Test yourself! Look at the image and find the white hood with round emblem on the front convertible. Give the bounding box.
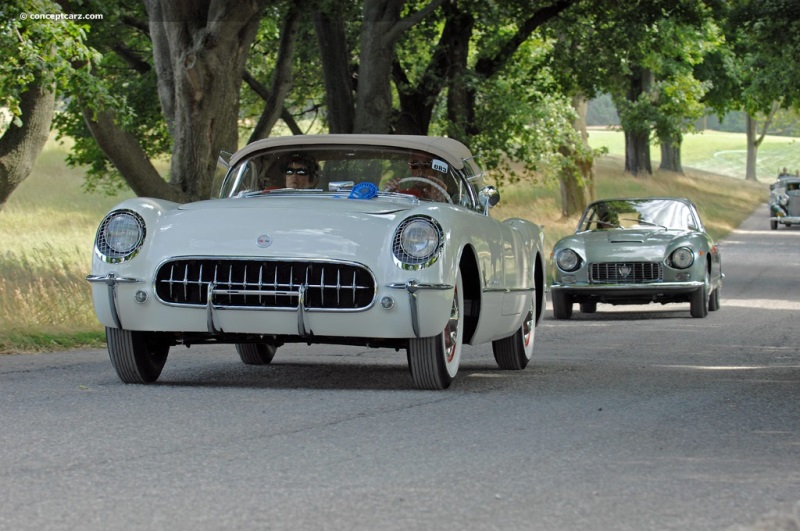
[148,196,428,260]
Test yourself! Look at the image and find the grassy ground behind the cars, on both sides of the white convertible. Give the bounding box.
[0,130,780,353]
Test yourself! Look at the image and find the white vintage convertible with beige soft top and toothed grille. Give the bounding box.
[87,135,545,389]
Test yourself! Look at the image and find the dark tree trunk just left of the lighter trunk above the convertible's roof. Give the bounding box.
[314,12,355,133]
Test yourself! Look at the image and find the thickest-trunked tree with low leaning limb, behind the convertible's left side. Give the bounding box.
[61,0,266,201]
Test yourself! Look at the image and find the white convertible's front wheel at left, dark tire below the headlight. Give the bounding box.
[106,327,169,383]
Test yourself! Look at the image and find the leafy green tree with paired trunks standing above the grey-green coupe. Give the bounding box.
[558,0,713,179]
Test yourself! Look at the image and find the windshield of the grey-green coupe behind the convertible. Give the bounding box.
[578,199,700,232]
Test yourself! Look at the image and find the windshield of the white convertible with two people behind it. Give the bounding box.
[220,145,479,212]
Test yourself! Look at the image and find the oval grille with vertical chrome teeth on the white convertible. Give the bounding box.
[156,258,375,310]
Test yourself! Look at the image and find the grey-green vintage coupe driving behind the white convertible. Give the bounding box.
[550,197,723,319]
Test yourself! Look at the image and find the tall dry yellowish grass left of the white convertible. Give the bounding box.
[0,140,130,353]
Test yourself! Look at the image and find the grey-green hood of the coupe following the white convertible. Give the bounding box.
[557,228,691,262]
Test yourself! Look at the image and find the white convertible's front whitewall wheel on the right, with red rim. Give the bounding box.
[407,271,464,390]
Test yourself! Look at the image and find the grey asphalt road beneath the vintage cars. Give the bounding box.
[0,207,800,531]
